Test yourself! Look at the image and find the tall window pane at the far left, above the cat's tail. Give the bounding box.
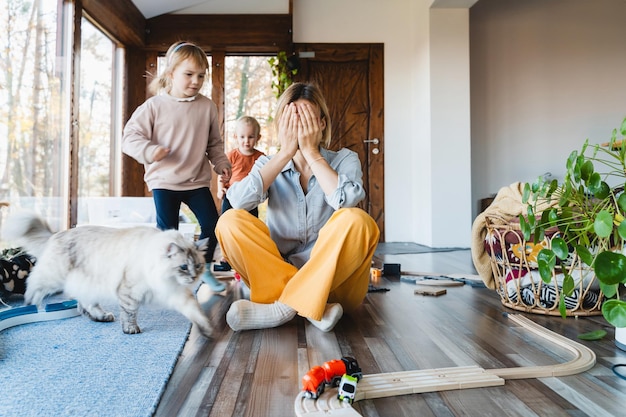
[0,0,71,232]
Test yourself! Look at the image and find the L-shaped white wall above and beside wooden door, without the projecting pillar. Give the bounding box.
[293,0,428,241]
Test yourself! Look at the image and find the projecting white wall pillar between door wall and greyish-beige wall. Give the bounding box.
[424,9,472,247]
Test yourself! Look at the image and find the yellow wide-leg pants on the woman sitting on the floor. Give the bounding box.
[216,208,380,320]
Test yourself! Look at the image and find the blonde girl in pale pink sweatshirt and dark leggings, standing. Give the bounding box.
[122,42,231,292]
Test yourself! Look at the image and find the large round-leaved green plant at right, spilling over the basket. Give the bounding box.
[520,118,626,348]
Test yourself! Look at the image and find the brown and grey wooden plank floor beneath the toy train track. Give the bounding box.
[155,250,626,417]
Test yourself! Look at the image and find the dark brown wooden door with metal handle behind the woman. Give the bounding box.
[295,43,385,241]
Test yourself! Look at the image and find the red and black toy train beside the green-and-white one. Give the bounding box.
[302,356,363,399]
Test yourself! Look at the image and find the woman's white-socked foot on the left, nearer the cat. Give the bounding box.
[226,300,296,331]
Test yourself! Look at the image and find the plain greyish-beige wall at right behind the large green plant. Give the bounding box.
[470,0,626,219]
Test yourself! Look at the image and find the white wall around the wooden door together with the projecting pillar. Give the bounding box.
[293,0,471,247]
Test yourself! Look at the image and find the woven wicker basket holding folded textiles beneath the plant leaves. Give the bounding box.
[485,216,603,316]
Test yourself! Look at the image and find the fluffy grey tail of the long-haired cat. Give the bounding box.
[2,211,53,258]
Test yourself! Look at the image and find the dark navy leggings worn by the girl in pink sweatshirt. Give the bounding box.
[152,187,218,263]
